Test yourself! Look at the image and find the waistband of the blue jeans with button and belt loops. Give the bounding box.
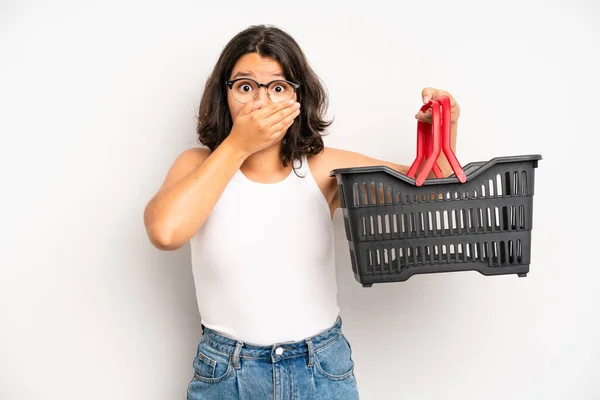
[201,316,342,361]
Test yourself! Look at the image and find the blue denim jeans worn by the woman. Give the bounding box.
[187,318,358,400]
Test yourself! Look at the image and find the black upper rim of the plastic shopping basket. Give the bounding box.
[329,154,542,186]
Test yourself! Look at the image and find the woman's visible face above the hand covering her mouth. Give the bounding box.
[227,53,296,120]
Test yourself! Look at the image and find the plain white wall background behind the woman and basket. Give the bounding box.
[0,0,600,400]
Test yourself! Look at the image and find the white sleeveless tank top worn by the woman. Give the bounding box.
[190,157,340,345]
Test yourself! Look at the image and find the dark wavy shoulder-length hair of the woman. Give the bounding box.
[196,25,333,166]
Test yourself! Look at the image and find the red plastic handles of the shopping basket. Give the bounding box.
[406,96,467,186]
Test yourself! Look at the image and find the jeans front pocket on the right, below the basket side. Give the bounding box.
[315,334,354,380]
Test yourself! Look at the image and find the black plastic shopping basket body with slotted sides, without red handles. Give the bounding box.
[331,155,542,287]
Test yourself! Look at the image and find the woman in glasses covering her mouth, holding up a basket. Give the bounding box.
[144,26,459,400]
